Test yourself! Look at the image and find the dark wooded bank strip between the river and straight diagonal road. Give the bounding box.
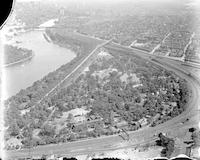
[7,28,99,104]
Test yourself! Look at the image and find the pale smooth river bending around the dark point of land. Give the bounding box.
[4,27,76,99]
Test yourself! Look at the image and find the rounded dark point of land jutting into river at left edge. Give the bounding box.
[2,45,34,67]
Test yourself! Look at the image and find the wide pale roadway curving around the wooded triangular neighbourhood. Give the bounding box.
[7,44,200,159]
